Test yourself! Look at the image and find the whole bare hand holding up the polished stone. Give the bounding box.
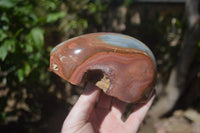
[62,84,155,133]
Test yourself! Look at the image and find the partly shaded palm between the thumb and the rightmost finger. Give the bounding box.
[89,93,128,133]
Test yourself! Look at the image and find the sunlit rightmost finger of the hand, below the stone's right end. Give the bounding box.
[125,94,155,133]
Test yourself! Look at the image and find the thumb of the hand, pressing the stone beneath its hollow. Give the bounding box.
[62,84,100,133]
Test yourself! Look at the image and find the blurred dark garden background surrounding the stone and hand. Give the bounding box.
[0,0,200,133]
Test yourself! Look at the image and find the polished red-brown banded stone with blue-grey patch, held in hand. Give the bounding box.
[50,33,156,103]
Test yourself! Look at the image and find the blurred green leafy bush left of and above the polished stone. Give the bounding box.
[0,0,106,123]
